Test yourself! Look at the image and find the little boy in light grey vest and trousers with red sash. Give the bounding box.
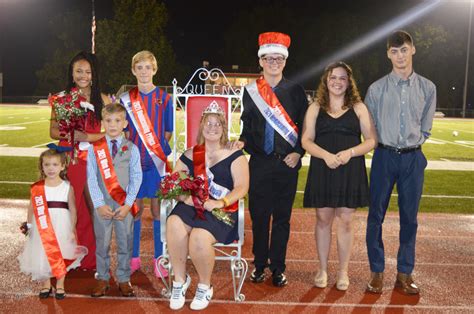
[87,104,142,297]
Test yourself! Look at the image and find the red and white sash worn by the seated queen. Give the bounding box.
[193,144,238,212]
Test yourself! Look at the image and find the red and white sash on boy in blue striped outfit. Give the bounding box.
[120,87,171,177]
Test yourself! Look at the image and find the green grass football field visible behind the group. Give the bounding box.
[0,105,474,213]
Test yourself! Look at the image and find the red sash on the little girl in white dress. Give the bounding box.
[31,180,67,278]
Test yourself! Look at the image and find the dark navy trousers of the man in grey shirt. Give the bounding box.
[366,148,427,274]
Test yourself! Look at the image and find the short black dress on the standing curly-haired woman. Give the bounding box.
[303,109,369,208]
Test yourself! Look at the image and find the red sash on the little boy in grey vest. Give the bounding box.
[93,137,138,217]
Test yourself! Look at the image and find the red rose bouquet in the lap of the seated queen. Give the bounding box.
[157,171,235,227]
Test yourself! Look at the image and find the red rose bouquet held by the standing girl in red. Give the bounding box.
[49,87,94,162]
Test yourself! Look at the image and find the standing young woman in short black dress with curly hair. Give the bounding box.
[301,62,377,290]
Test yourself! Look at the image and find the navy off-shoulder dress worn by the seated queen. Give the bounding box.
[170,150,243,244]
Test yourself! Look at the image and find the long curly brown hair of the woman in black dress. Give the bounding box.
[316,61,362,112]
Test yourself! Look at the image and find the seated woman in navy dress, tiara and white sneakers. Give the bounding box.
[166,104,249,310]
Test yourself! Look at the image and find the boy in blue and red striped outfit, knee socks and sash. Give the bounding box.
[120,50,174,277]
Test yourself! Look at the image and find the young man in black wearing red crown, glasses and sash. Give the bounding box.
[235,32,308,287]
